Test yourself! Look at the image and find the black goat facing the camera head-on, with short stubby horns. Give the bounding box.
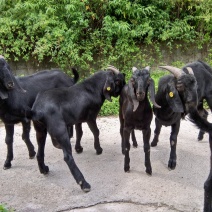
[119,67,160,175]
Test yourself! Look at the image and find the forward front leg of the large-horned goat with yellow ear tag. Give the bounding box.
[168,120,180,170]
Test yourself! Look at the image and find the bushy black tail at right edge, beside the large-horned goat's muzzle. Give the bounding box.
[188,110,212,133]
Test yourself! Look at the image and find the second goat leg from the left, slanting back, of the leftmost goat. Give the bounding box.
[22,120,36,159]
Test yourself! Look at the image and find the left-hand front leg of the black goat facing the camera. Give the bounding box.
[123,127,131,172]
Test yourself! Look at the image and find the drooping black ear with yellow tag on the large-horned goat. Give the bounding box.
[166,83,184,113]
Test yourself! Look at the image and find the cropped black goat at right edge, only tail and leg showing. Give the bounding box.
[189,110,212,212]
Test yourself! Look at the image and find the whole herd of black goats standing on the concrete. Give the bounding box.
[0,56,212,212]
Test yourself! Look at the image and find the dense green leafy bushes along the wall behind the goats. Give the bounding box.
[0,0,212,72]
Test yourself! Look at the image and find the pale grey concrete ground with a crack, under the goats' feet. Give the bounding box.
[0,114,211,212]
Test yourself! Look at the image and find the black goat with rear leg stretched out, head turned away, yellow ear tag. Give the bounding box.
[29,67,125,191]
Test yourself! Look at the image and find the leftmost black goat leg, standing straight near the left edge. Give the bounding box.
[4,124,14,170]
